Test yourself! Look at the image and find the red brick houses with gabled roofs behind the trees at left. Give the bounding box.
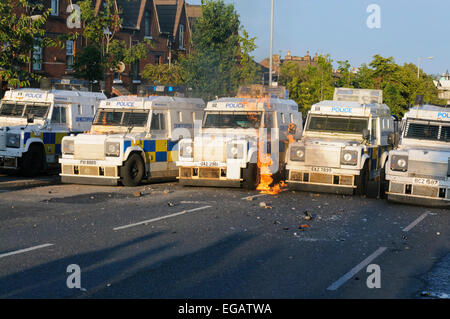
[0,0,201,95]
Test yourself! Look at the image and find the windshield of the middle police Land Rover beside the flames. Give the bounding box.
[203,112,261,129]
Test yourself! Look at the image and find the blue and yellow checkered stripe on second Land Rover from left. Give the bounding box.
[124,140,178,163]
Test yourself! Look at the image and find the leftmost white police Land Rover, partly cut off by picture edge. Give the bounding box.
[0,89,106,176]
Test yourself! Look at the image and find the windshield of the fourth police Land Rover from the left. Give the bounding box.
[307,115,368,134]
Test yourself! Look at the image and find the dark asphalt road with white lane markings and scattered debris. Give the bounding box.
[0,176,450,299]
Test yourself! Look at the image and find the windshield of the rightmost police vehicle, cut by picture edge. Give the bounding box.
[404,121,450,142]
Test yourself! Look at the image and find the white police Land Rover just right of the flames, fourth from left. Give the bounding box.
[286,88,396,196]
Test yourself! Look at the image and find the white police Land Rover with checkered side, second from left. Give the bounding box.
[60,90,205,186]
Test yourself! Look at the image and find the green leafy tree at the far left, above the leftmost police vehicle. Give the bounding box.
[0,0,63,87]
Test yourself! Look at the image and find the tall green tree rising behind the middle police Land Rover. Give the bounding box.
[181,0,256,100]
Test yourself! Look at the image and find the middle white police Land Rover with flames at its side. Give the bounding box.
[177,86,302,189]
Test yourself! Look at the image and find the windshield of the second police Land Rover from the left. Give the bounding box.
[93,109,149,127]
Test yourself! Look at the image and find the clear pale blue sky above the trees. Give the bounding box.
[187,0,450,74]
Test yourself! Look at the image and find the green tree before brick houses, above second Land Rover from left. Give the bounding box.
[74,0,151,84]
